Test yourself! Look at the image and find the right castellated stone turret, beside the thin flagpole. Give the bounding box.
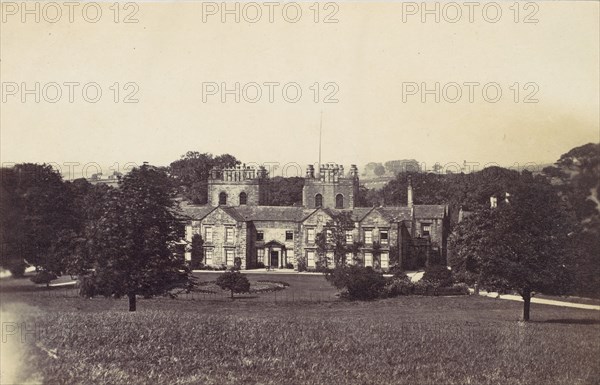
[302,163,359,209]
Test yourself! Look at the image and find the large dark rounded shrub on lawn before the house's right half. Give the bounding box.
[325,266,385,301]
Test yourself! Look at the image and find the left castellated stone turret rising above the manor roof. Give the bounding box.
[208,164,269,206]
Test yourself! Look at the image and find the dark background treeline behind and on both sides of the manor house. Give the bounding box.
[0,144,600,295]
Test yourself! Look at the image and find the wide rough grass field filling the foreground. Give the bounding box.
[0,275,600,385]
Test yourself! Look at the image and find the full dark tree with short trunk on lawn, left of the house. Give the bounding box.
[84,165,194,311]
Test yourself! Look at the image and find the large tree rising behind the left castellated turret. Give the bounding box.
[169,151,240,204]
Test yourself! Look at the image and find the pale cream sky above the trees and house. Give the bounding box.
[0,1,600,178]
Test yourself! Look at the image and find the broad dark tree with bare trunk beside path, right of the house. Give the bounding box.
[449,181,573,321]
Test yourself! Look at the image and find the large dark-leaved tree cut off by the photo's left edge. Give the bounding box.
[0,163,77,276]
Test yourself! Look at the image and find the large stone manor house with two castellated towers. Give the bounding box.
[183,164,448,270]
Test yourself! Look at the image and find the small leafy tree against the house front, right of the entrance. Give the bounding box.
[315,212,355,267]
